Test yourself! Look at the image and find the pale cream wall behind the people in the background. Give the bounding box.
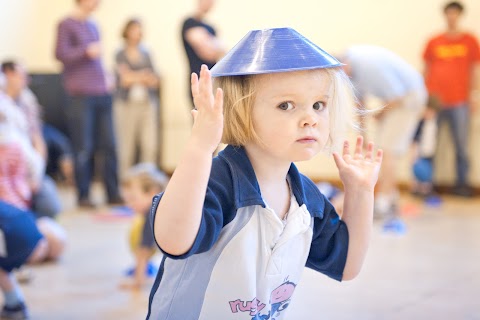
[0,0,480,185]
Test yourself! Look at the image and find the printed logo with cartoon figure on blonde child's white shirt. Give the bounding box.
[229,280,297,320]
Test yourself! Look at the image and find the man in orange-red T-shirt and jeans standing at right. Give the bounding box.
[423,1,480,197]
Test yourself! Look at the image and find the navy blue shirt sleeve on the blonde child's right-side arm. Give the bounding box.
[306,188,348,281]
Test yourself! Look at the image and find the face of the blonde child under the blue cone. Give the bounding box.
[248,70,331,162]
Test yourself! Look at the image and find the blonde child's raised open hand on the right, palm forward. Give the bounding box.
[333,136,383,191]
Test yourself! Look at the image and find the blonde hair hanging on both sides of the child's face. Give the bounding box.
[215,67,358,152]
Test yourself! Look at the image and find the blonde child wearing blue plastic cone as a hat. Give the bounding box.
[147,28,382,319]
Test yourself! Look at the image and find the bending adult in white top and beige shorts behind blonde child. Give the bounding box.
[343,45,427,218]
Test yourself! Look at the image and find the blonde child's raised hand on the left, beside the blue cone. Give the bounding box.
[191,65,223,153]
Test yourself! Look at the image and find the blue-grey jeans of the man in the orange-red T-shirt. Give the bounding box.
[438,104,470,187]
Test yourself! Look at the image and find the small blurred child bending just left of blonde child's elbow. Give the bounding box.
[120,163,168,289]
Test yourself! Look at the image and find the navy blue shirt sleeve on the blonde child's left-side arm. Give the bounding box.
[150,158,235,259]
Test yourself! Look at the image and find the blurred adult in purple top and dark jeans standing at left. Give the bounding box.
[55,0,121,208]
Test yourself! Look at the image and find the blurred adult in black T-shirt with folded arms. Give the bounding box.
[182,0,225,105]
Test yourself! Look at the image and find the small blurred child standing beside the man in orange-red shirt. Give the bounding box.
[412,96,440,197]
